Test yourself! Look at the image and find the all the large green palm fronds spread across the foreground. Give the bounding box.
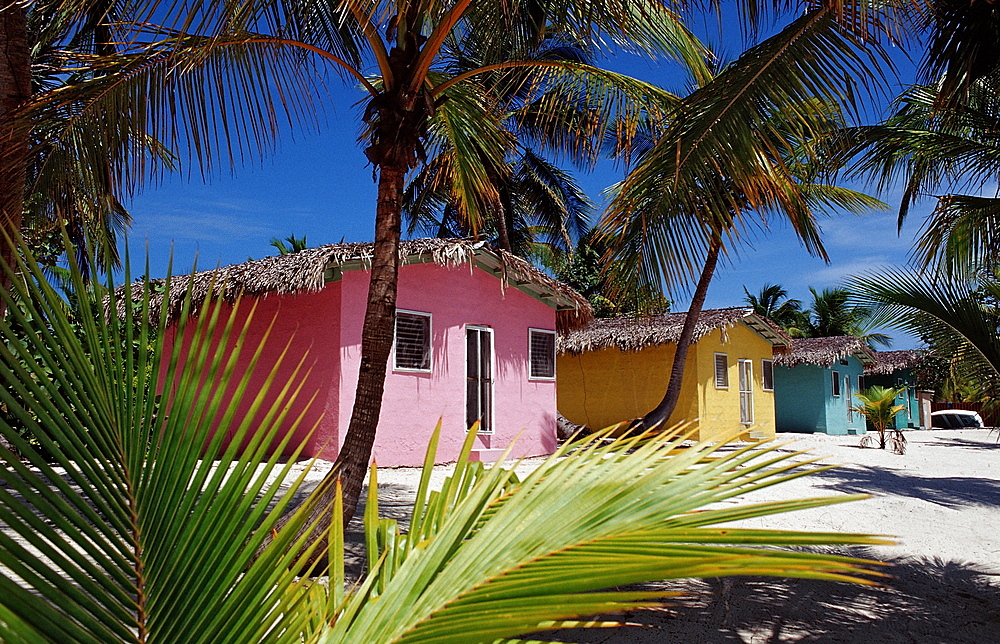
[0,248,896,644]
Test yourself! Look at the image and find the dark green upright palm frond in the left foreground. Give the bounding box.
[0,239,332,643]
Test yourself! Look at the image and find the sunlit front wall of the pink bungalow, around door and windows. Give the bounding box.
[340,264,556,467]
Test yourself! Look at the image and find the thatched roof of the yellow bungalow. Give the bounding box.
[559,308,791,354]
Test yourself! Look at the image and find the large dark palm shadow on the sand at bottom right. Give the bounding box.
[543,551,1000,644]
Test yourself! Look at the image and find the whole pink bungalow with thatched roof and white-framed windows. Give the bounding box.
[148,239,591,467]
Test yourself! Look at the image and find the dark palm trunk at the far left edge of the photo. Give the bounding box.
[0,3,31,315]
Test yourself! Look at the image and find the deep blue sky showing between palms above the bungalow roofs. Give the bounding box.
[123,16,929,348]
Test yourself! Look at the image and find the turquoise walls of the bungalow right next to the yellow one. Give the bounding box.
[774,356,865,435]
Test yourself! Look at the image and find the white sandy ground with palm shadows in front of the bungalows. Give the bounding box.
[300,430,1000,644]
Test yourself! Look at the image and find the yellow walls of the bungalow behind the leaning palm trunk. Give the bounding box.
[556,324,774,439]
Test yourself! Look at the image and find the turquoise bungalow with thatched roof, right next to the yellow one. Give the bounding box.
[774,336,875,435]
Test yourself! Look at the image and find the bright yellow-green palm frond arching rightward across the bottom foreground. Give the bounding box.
[314,431,884,642]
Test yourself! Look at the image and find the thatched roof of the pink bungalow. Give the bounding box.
[118,238,593,331]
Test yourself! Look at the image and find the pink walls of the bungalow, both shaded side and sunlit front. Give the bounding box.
[163,264,556,467]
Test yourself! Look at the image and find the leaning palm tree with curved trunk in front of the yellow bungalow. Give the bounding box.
[602,9,881,427]
